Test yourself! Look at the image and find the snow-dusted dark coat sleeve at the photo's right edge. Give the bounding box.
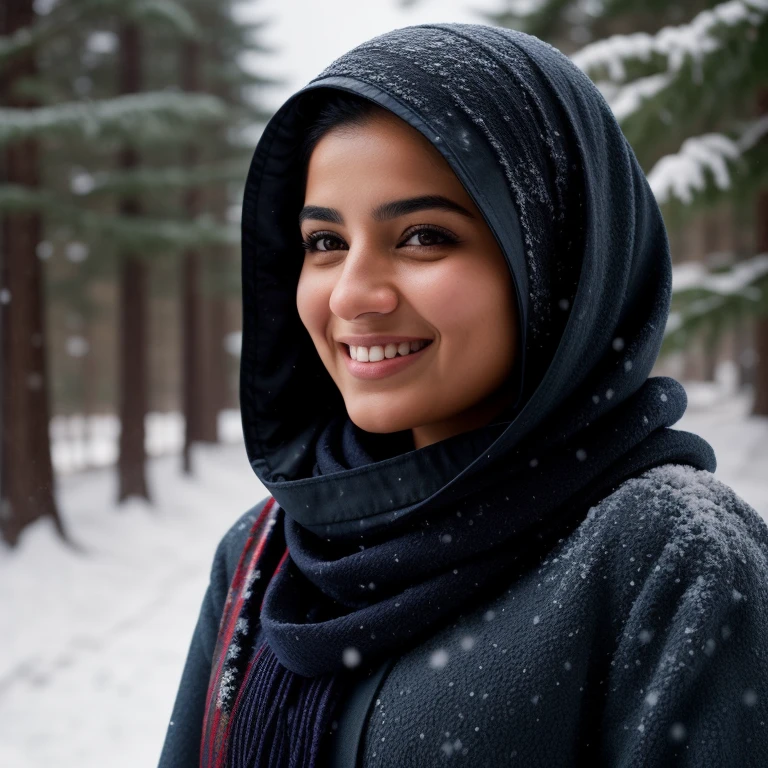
[602,473,768,768]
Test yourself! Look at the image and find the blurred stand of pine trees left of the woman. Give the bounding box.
[0,0,280,545]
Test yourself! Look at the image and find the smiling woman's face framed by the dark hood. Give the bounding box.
[296,105,517,448]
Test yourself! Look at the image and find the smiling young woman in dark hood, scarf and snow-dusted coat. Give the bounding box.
[160,24,768,768]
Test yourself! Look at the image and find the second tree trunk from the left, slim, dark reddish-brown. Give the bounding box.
[118,23,150,502]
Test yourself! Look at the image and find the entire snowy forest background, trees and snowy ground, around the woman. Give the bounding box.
[0,0,768,768]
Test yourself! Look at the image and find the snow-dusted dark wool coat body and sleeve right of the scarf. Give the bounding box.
[344,465,768,768]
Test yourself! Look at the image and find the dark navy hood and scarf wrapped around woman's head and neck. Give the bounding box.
[241,24,715,677]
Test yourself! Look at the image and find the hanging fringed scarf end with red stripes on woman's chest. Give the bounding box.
[200,498,340,768]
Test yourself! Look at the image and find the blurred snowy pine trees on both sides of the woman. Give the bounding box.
[0,0,768,545]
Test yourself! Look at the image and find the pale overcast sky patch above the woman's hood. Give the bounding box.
[238,0,505,110]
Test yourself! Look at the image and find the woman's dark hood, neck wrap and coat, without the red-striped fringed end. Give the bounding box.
[160,24,768,768]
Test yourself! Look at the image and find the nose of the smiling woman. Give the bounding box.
[330,249,398,320]
